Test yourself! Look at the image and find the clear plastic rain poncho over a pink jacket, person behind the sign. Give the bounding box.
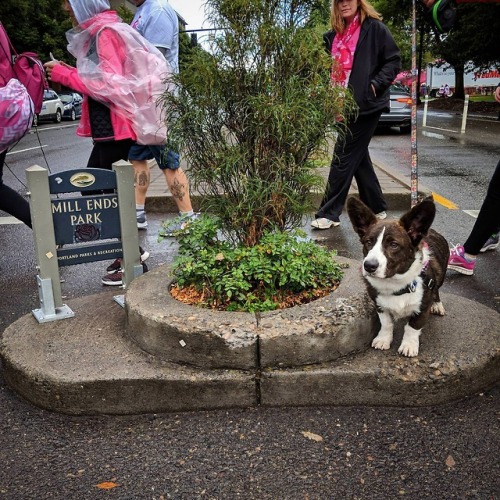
[66,11,172,145]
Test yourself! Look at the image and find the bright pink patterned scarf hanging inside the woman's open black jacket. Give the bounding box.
[331,14,361,87]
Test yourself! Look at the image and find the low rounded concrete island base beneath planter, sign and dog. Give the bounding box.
[0,264,500,415]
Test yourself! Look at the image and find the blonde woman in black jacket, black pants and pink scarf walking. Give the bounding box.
[311,0,401,229]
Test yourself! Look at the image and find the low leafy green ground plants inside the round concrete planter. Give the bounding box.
[160,215,342,312]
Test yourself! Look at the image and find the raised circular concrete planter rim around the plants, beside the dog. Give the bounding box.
[125,258,377,370]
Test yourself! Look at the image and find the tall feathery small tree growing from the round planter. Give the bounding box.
[164,0,354,246]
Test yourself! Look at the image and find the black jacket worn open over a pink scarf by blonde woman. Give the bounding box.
[323,17,401,115]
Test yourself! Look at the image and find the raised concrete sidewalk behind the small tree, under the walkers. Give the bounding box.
[146,159,431,213]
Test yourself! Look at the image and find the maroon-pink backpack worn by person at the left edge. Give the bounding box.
[0,22,49,114]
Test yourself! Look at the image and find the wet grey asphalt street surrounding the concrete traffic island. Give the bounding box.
[0,113,500,500]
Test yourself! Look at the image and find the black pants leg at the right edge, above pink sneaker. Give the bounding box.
[464,161,500,255]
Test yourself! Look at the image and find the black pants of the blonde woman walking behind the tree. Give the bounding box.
[316,112,387,221]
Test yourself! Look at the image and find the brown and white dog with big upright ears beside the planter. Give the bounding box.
[347,197,449,356]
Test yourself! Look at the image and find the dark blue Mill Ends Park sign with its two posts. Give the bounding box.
[26,161,143,323]
